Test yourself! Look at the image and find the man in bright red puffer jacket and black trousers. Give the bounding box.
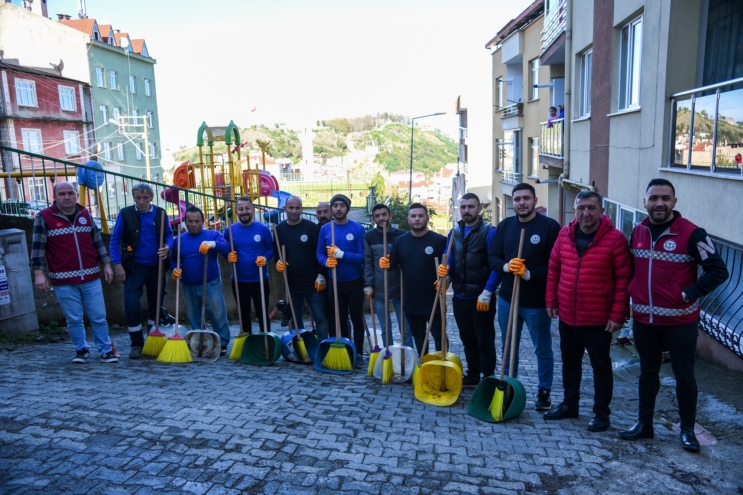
[544,191,632,431]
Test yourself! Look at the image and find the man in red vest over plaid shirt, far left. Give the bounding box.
[30,182,118,364]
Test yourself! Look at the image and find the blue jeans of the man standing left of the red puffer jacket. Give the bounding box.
[498,297,555,390]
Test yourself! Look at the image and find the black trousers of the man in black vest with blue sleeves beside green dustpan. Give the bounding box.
[452,296,496,380]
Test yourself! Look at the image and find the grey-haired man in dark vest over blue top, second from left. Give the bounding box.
[109,184,173,359]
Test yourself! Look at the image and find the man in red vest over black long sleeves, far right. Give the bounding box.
[619,179,729,452]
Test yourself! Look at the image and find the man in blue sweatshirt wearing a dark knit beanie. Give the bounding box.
[317,194,364,367]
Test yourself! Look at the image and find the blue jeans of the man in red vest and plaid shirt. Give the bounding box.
[54,280,111,354]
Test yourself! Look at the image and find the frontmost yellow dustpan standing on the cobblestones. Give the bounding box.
[415,360,462,406]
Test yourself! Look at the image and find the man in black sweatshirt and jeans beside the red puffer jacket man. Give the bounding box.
[488,183,560,411]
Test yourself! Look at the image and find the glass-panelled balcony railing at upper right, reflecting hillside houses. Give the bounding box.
[668,77,743,175]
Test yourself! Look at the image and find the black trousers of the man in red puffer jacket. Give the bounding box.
[559,321,614,416]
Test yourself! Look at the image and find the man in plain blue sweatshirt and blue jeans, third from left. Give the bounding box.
[170,206,230,356]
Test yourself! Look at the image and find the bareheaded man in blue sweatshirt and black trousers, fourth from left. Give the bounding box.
[224,197,274,333]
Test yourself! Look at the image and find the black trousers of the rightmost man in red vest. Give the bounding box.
[632,320,698,430]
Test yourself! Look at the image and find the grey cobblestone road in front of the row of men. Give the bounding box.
[0,296,743,495]
